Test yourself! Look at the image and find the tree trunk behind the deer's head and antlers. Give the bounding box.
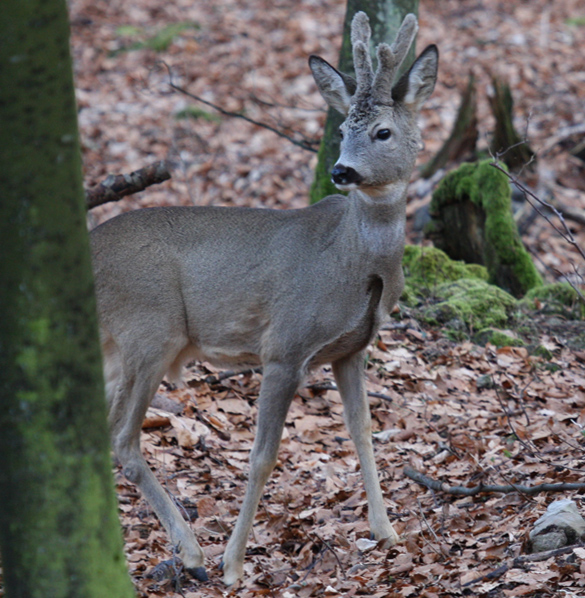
[310,0,419,203]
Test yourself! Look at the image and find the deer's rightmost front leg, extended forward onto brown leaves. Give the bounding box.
[332,352,399,548]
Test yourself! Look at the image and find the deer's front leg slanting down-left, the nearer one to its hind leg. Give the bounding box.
[223,363,300,585]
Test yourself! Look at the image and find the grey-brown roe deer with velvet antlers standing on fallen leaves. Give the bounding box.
[91,12,438,585]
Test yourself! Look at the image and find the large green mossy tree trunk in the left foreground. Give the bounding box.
[0,0,134,598]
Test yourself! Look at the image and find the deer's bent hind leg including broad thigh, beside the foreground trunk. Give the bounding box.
[104,337,207,581]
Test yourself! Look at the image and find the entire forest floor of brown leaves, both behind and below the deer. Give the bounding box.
[19,0,585,598]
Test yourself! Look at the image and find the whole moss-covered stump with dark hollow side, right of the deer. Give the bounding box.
[426,161,542,297]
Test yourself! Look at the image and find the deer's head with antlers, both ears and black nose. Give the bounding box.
[309,12,439,198]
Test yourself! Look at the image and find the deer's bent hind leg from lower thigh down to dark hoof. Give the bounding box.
[110,342,207,581]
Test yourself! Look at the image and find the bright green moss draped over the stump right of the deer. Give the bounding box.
[430,160,543,296]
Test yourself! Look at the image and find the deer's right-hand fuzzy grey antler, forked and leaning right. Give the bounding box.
[372,14,418,104]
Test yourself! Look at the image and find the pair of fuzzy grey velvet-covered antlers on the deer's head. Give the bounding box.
[351,11,418,105]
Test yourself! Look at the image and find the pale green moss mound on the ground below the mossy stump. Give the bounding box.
[422,278,516,330]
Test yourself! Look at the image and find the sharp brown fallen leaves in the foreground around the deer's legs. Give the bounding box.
[100,330,585,597]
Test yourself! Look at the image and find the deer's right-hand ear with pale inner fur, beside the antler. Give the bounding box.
[392,44,439,112]
